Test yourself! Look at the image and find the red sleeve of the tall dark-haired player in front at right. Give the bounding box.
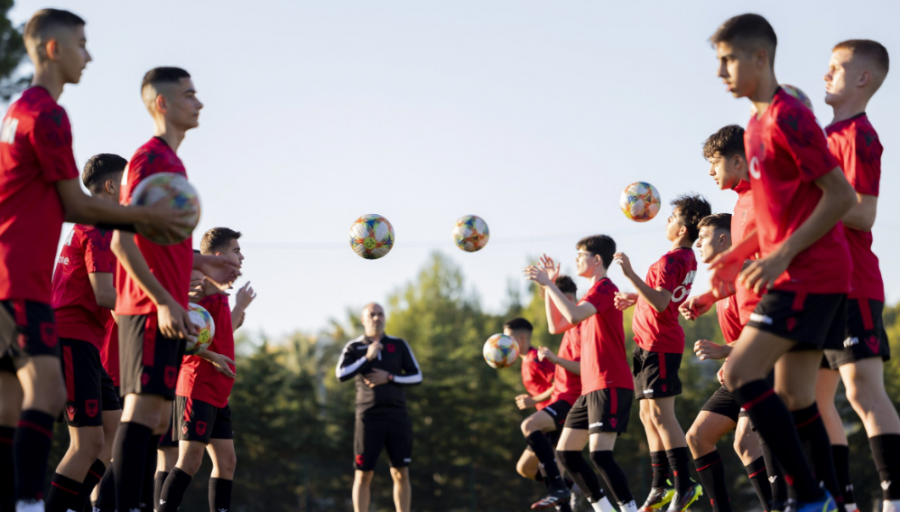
[777,107,840,182]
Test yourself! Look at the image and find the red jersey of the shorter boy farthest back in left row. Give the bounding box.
[175,293,234,407]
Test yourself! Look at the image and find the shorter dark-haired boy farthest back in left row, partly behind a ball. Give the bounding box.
[157,228,244,512]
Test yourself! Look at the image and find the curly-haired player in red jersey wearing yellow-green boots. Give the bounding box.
[615,195,711,512]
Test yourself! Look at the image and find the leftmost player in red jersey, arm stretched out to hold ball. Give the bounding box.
[0,9,185,512]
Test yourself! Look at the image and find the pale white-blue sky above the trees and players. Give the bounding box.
[12,0,900,336]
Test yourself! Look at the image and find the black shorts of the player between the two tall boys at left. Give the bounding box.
[59,338,122,427]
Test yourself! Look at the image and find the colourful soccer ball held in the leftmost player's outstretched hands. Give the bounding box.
[131,172,200,245]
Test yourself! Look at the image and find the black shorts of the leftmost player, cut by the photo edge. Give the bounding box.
[0,299,60,373]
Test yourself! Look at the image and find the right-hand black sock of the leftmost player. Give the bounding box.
[13,409,54,500]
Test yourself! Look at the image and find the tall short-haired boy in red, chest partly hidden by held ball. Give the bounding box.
[112,67,235,512]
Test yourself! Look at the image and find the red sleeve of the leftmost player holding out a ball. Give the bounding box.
[31,107,79,183]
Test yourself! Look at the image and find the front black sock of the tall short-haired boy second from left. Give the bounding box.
[112,421,152,512]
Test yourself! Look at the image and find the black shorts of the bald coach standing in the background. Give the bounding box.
[353,412,412,471]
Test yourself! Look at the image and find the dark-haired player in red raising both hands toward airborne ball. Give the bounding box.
[524,235,637,512]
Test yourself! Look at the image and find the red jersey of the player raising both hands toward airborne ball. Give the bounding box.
[579,277,634,395]
